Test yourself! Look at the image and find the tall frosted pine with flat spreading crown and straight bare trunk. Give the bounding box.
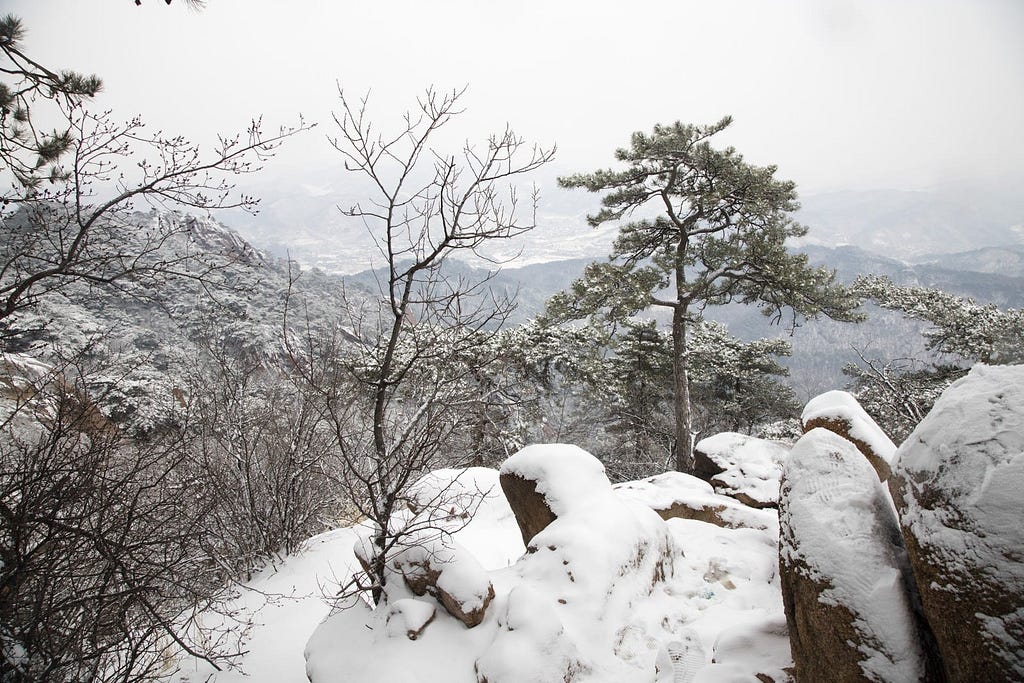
[549,117,858,471]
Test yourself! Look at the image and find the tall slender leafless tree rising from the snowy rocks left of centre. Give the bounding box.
[294,89,553,601]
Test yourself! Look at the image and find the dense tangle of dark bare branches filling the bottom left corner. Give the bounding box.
[0,355,238,683]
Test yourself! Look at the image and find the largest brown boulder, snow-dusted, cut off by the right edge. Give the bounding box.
[889,366,1024,682]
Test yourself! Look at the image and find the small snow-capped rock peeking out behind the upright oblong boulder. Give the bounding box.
[800,391,896,481]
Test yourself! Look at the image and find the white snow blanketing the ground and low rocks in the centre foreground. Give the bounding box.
[187,445,792,683]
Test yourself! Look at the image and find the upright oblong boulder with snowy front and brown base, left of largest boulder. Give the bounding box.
[779,429,928,682]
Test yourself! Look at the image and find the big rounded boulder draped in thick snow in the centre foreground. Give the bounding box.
[475,444,688,683]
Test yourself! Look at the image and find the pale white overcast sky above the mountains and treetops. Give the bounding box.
[8,0,1024,194]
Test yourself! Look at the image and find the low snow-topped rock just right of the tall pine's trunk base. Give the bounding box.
[693,432,790,508]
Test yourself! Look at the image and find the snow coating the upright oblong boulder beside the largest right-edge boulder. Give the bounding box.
[779,428,924,682]
